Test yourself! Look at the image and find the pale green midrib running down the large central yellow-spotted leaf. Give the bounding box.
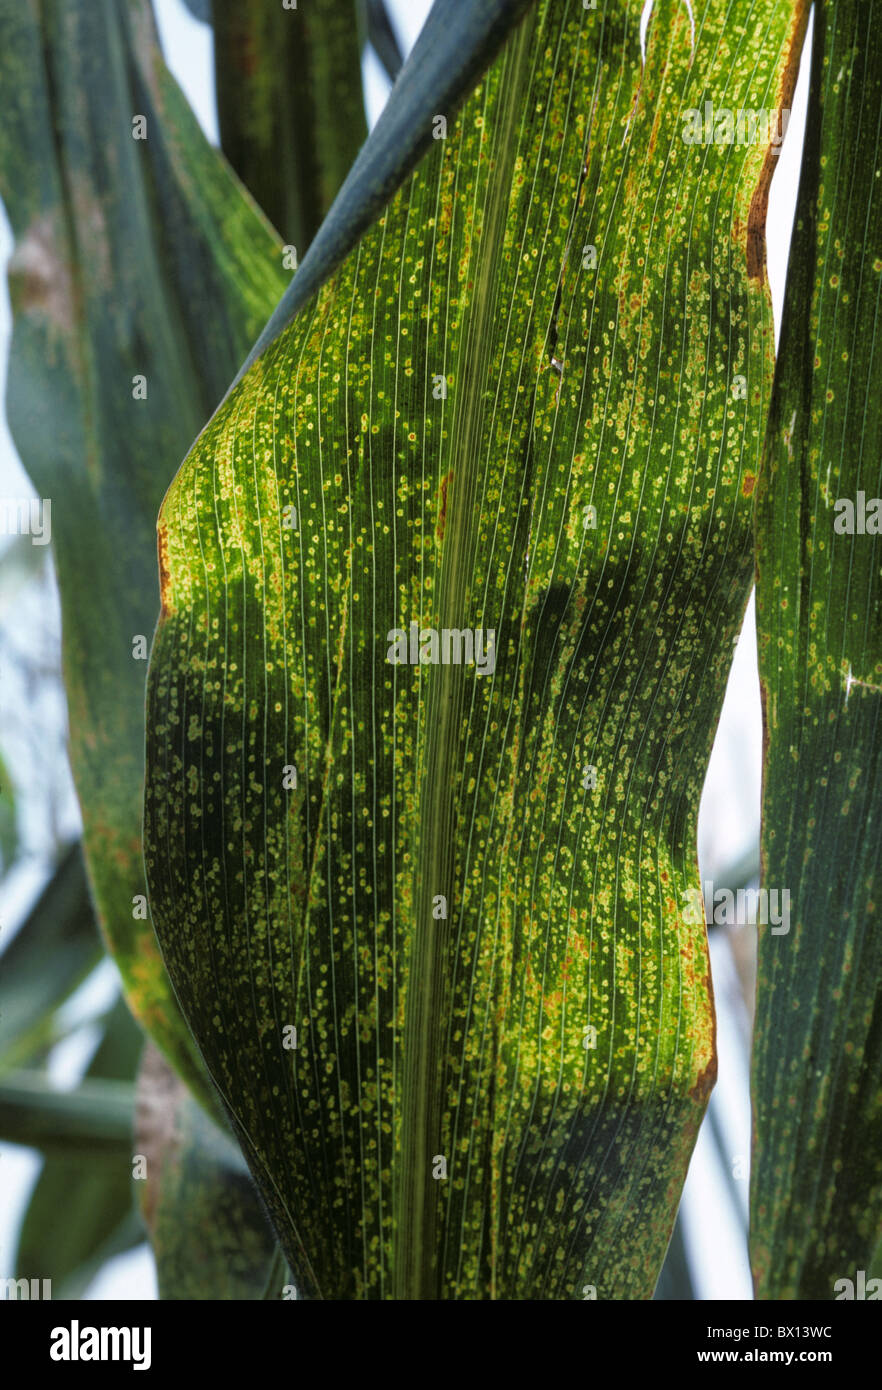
[393,10,535,1300]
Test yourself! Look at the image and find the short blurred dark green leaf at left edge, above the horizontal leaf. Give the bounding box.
[0,842,101,1074]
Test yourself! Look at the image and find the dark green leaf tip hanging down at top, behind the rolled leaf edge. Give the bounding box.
[213,0,367,254]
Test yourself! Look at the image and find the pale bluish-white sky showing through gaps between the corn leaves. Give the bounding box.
[0,0,811,1298]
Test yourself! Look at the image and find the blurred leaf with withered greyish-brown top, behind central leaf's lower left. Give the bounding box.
[135,1048,280,1300]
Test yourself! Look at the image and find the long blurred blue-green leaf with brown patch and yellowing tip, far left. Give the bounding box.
[0,0,288,1105]
